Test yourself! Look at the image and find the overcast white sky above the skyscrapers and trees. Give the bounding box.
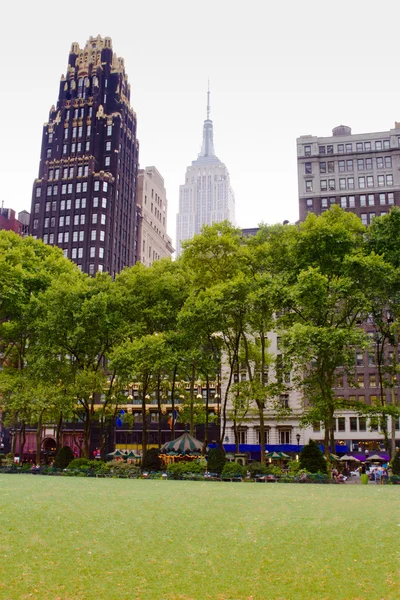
[0,0,400,245]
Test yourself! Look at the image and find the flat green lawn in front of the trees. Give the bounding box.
[0,475,400,600]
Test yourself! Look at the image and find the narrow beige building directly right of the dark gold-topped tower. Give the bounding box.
[137,167,174,266]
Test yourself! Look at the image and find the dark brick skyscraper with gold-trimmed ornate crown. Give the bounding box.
[30,36,139,276]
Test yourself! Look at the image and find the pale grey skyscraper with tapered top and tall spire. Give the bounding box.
[176,91,235,256]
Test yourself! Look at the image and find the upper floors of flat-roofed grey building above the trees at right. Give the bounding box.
[297,123,400,225]
